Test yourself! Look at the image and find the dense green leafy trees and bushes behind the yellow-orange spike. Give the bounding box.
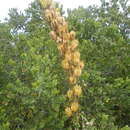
[0,0,130,130]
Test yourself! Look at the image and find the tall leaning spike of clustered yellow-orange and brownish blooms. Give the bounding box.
[39,0,84,117]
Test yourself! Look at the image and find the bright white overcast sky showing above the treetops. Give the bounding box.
[0,0,100,20]
